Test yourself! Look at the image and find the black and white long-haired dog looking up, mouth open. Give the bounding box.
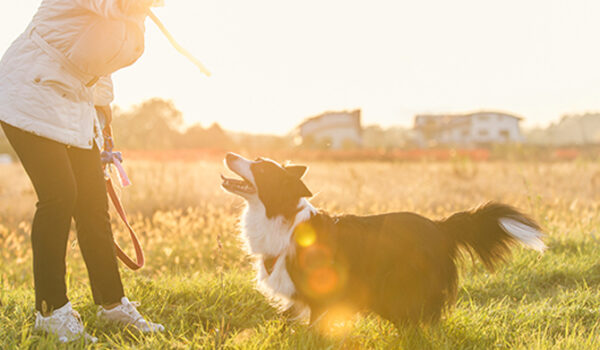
[222,153,545,326]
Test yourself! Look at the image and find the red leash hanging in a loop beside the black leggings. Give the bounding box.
[101,113,145,271]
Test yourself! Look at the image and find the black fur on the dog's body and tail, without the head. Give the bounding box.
[286,203,539,324]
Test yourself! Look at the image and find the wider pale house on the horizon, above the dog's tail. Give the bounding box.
[414,111,524,147]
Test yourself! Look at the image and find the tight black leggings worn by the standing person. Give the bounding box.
[0,122,123,311]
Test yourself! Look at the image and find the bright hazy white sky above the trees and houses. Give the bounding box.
[0,0,600,134]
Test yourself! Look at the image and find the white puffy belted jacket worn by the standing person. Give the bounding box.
[0,0,153,149]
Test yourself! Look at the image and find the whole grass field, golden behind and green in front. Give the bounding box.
[0,161,600,349]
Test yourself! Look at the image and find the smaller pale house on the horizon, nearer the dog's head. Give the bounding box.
[297,109,363,149]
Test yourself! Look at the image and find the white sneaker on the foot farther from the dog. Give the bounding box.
[34,302,98,343]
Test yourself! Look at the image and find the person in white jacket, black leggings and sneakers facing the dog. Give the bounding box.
[0,0,164,342]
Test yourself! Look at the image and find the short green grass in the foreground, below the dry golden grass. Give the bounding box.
[0,241,600,349]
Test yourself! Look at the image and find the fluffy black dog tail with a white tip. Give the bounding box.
[438,202,546,270]
